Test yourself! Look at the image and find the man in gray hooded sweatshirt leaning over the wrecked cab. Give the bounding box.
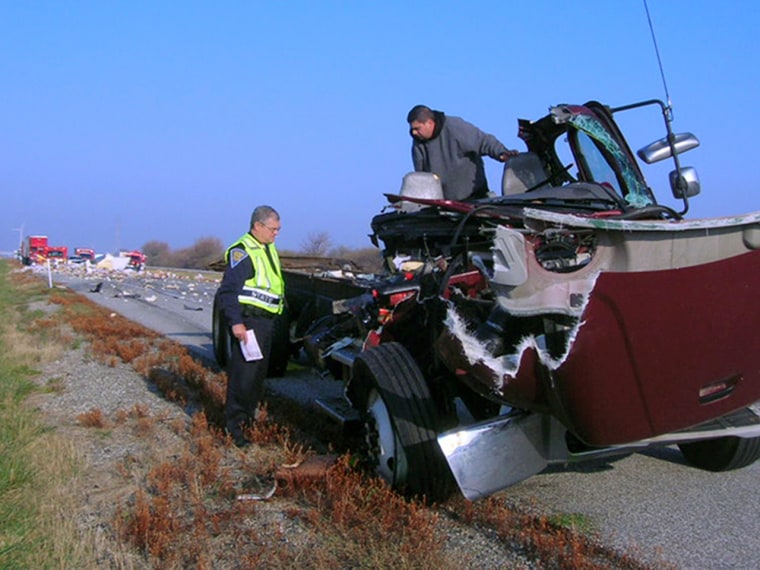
[406,105,518,200]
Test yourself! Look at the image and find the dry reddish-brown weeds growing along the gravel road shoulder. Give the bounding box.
[17,277,664,570]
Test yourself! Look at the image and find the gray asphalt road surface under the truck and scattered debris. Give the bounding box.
[53,266,760,570]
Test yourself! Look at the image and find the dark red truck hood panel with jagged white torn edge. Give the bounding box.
[438,240,760,445]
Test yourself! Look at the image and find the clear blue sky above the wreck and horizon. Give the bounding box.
[0,0,760,252]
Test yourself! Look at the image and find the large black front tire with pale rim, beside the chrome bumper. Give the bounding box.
[351,342,455,501]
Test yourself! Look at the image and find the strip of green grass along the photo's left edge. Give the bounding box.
[0,261,93,570]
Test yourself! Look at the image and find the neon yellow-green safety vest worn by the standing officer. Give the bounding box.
[225,233,285,314]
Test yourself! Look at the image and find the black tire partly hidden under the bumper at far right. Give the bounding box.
[678,436,760,471]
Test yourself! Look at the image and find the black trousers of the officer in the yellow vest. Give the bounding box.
[224,310,274,442]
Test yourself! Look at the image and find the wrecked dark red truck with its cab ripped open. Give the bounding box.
[215,100,760,499]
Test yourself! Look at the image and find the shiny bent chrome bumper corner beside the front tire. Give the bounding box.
[438,414,548,501]
